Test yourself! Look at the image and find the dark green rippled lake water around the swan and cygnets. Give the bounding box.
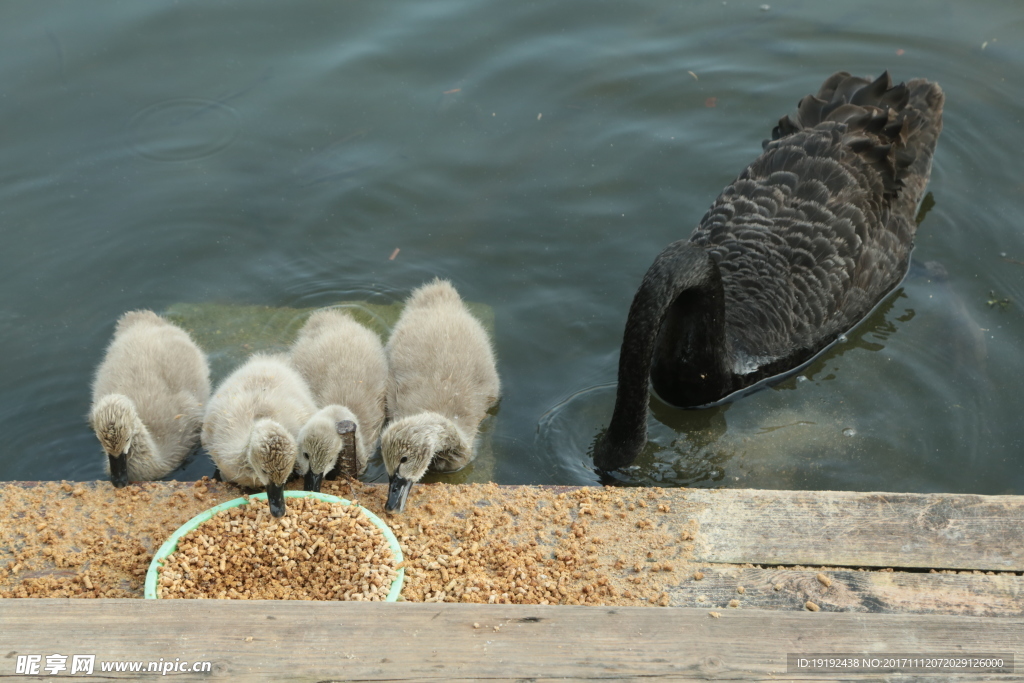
[0,0,1024,494]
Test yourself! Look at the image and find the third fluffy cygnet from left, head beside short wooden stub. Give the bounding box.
[291,308,388,490]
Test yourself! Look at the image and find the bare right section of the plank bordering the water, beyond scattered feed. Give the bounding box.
[684,489,1024,571]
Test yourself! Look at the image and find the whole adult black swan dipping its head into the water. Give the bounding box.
[594,72,944,470]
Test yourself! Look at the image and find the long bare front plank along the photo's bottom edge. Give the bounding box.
[0,599,1024,681]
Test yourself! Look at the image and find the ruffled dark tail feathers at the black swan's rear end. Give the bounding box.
[766,72,943,205]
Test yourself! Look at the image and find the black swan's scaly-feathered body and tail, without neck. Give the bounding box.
[690,72,943,374]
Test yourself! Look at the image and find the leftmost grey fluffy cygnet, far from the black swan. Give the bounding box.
[89,310,210,486]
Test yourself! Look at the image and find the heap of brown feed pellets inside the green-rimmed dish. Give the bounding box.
[157,498,398,600]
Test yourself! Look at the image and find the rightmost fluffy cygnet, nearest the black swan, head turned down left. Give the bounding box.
[381,280,501,511]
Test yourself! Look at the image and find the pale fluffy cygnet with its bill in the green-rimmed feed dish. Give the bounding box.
[203,353,316,517]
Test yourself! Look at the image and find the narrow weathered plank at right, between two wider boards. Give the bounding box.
[668,565,1024,616]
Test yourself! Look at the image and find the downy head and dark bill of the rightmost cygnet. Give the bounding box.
[381,413,450,512]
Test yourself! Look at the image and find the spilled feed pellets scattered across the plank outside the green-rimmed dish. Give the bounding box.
[0,480,698,605]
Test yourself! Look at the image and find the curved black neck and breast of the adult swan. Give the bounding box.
[594,241,732,469]
